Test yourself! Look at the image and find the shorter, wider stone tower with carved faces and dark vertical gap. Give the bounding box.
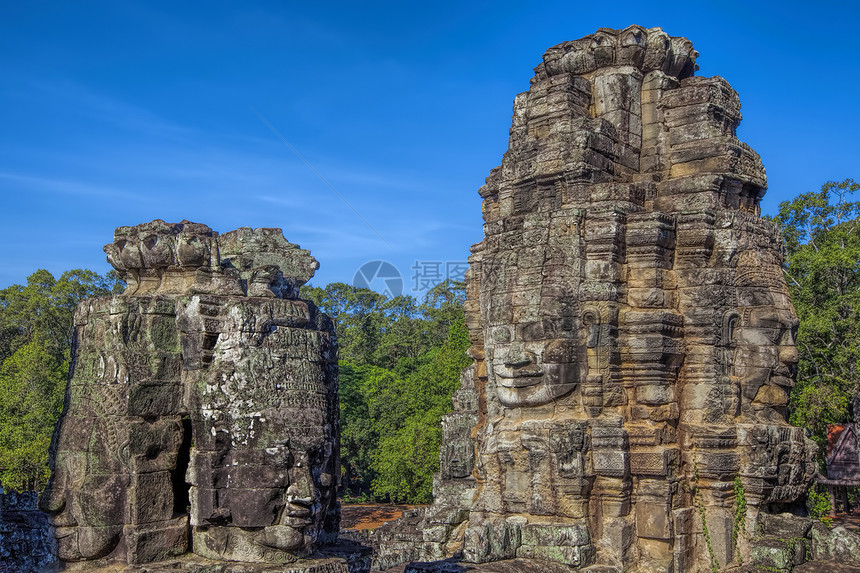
[41,220,345,571]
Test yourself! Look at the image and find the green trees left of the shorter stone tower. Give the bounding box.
[0,269,122,490]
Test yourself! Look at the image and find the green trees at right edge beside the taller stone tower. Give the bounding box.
[775,179,860,442]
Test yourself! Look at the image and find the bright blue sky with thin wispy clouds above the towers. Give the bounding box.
[0,0,860,292]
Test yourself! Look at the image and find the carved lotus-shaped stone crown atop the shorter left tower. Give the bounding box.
[104,219,319,298]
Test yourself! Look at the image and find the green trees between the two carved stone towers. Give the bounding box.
[310,281,470,502]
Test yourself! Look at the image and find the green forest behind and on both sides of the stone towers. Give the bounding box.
[0,179,860,503]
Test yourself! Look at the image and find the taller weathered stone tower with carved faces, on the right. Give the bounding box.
[374,26,816,573]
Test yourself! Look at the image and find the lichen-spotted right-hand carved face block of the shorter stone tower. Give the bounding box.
[183,297,338,563]
